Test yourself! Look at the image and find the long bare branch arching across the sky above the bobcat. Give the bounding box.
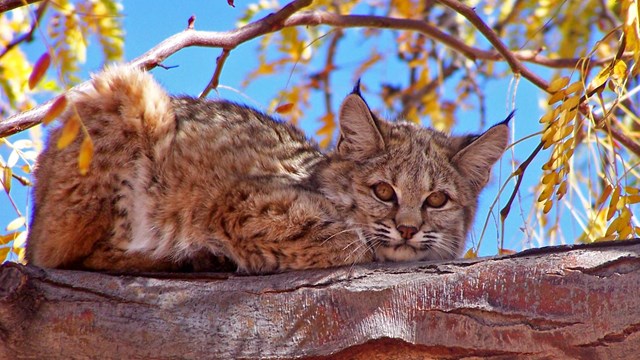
[0,0,632,137]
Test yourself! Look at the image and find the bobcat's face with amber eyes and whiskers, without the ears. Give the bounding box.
[352,124,476,261]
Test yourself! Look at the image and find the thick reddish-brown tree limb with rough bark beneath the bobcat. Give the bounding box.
[0,240,640,360]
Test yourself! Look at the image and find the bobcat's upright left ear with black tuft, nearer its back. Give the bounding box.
[336,90,385,160]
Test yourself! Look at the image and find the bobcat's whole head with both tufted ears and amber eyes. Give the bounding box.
[321,88,512,261]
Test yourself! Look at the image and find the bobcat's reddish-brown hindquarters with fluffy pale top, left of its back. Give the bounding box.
[27,66,175,269]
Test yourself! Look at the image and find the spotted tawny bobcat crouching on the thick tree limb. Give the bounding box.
[27,66,511,274]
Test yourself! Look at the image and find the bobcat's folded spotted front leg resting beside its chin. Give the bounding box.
[211,185,373,273]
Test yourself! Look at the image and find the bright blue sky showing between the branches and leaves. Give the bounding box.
[0,0,556,255]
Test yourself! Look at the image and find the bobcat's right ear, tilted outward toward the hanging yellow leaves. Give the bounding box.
[451,112,513,191]
